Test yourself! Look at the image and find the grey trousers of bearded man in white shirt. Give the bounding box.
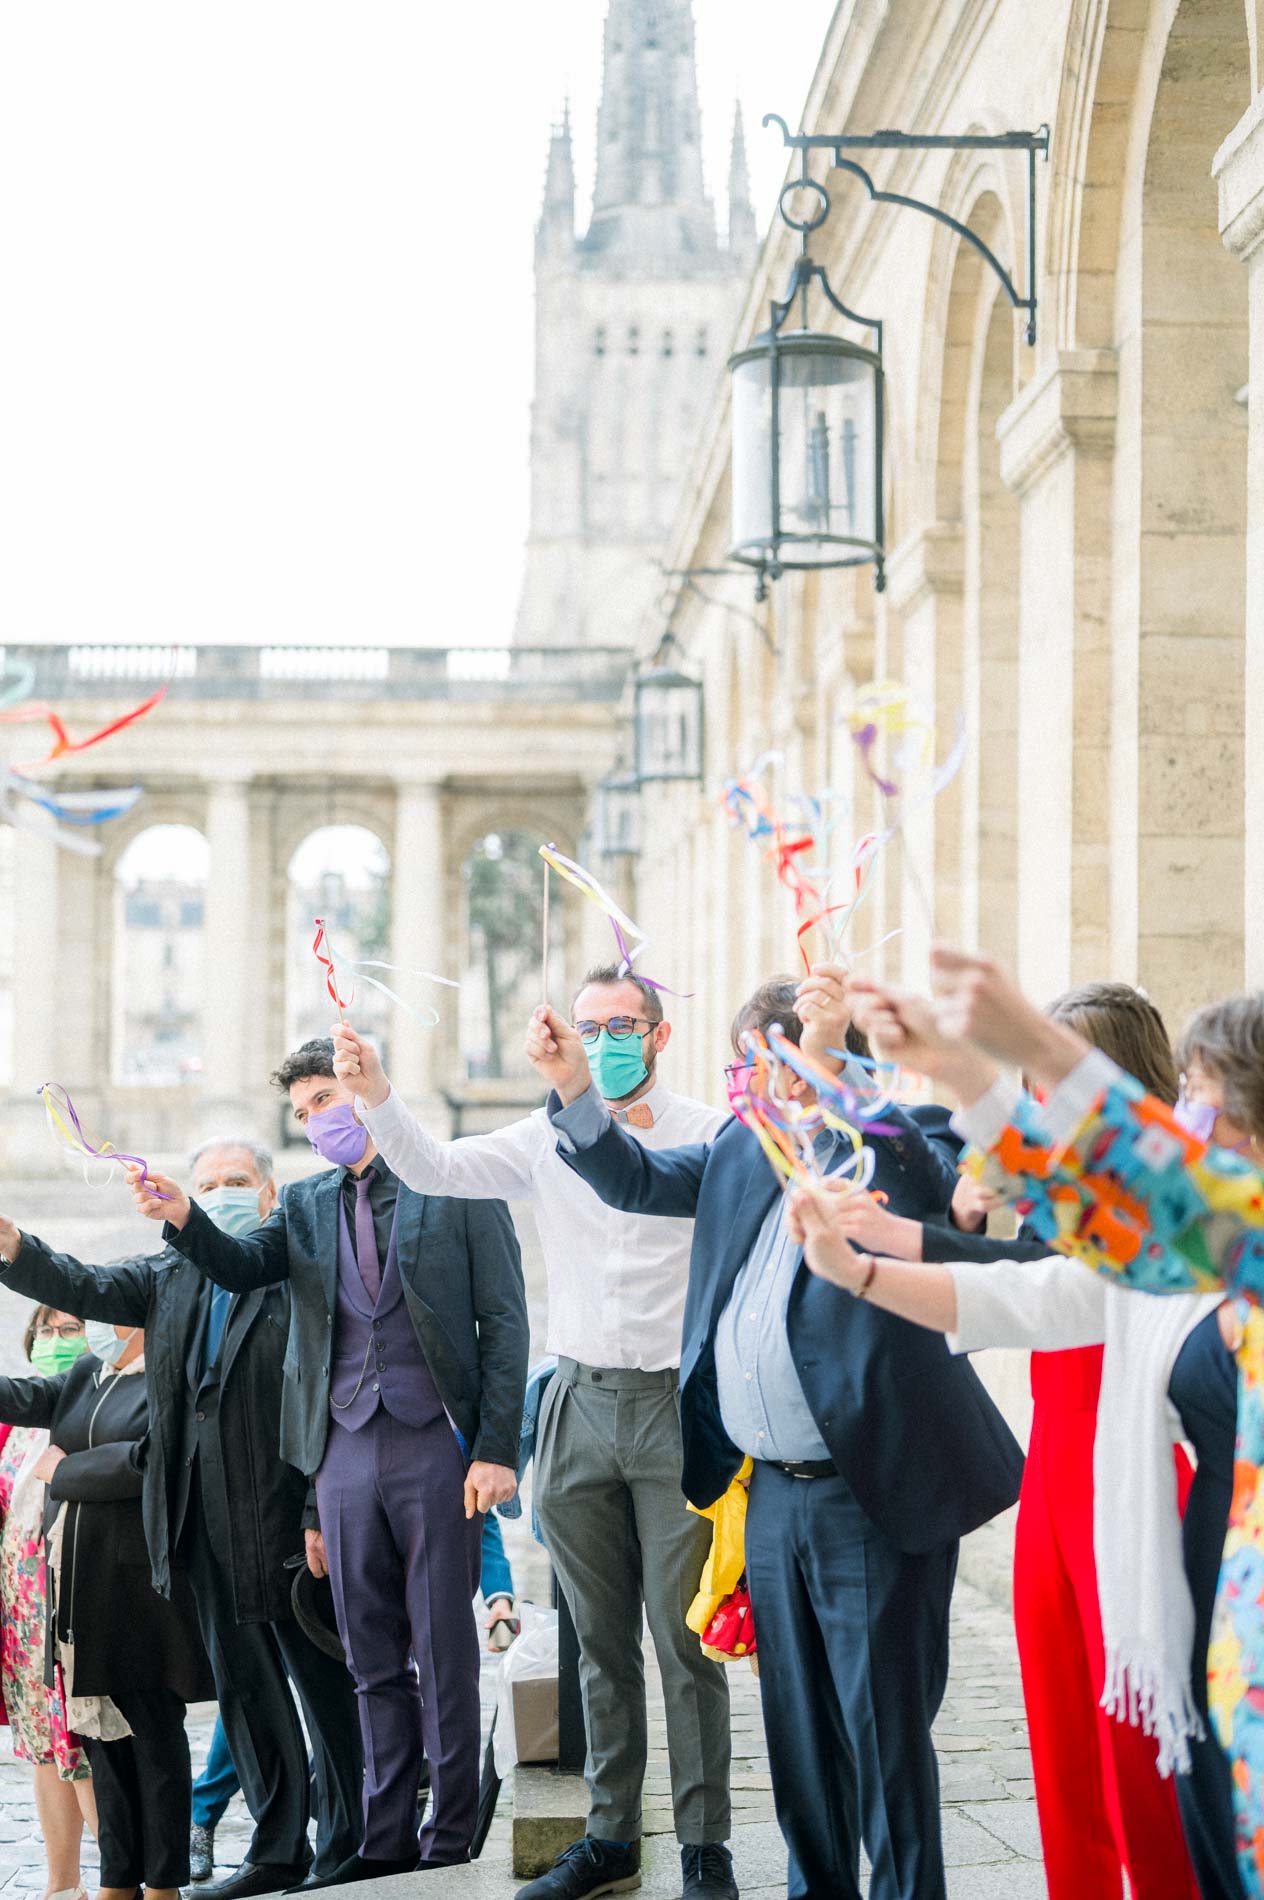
[534,1359,730,1845]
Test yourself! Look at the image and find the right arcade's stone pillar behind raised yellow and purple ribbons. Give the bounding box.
[888,523,964,988]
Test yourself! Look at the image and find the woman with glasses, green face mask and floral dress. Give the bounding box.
[0,1305,97,1900]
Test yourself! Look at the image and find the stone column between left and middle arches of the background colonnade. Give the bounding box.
[198,779,252,1136]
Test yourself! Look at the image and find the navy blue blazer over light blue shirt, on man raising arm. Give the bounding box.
[549,1094,1023,1552]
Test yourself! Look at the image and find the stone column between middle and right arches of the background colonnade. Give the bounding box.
[386,779,446,1132]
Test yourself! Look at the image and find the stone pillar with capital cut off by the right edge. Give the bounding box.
[1211,95,1264,988]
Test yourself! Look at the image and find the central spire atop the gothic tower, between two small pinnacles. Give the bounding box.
[584,0,717,257]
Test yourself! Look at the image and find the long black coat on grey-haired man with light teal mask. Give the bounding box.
[0,1233,308,1623]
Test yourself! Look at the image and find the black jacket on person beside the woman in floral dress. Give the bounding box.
[0,1353,215,1702]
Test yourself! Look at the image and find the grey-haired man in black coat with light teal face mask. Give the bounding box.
[0,1138,363,1900]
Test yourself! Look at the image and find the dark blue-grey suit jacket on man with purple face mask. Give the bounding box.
[165,1169,530,1476]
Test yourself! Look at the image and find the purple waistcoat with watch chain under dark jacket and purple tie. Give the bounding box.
[329,1195,443,1431]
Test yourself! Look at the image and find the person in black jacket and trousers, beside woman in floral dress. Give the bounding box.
[0,1315,215,1900]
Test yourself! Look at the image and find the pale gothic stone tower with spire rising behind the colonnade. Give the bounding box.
[515,0,756,646]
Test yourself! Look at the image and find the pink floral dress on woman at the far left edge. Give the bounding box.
[0,1427,91,1780]
